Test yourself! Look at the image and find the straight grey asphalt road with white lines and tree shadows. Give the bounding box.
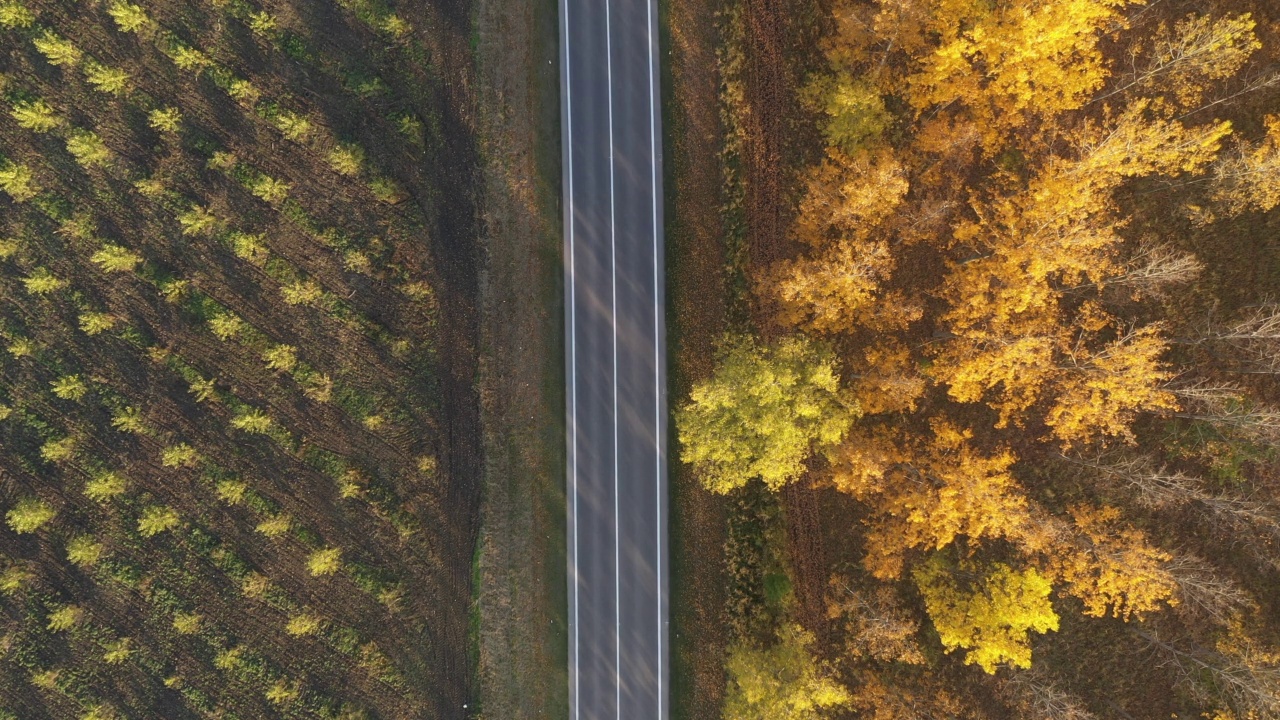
[559,0,669,720]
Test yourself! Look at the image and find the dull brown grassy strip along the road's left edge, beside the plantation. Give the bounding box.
[471,0,568,720]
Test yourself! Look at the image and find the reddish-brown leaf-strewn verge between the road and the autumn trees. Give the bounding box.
[662,0,731,720]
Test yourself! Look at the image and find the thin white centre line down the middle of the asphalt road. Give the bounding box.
[604,0,622,720]
